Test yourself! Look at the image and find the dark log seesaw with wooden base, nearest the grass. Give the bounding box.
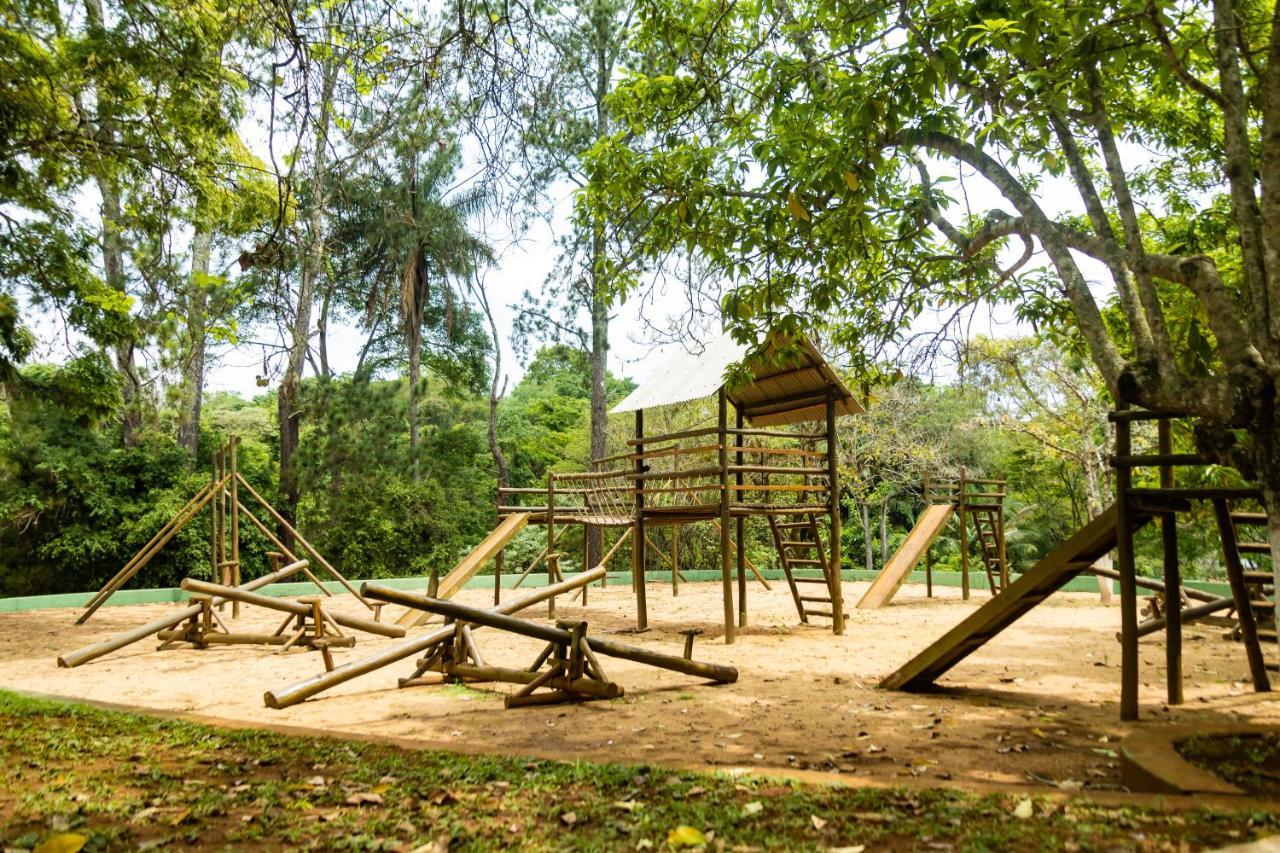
[361,583,737,708]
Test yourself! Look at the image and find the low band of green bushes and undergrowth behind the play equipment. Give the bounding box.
[0,341,1239,594]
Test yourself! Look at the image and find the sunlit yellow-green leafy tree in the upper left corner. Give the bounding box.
[0,0,257,446]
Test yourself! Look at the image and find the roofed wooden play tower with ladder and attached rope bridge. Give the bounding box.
[494,327,861,643]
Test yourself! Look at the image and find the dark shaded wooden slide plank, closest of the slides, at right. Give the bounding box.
[881,506,1152,692]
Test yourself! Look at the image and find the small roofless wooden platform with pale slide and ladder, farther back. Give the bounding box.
[858,470,1009,610]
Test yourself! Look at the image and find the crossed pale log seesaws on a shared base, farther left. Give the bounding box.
[58,560,404,669]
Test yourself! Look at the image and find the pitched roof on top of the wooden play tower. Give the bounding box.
[612,333,863,427]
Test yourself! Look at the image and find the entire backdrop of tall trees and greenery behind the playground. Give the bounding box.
[0,0,1259,594]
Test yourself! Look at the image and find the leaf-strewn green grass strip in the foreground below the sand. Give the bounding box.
[0,692,1280,850]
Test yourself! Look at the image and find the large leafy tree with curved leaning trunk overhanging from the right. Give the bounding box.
[591,0,1280,584]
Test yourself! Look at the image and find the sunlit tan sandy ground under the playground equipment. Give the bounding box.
[0,581,1280,788]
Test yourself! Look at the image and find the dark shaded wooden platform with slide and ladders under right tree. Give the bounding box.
[881,410,1276,720]
